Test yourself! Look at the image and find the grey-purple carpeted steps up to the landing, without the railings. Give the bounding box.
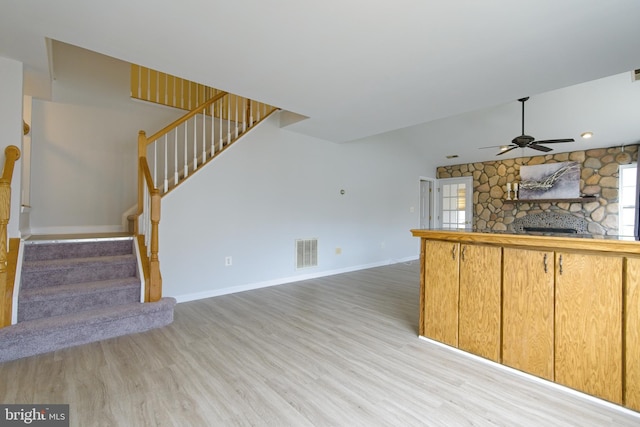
[0,237,175,362]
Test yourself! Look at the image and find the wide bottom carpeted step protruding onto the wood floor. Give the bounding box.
[0,298,176,362]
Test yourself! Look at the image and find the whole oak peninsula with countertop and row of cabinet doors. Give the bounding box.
[411,230,640,411]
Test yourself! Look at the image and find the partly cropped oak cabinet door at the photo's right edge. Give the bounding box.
[624,258,640,411]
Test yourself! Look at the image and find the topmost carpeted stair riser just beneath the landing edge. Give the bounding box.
[24,238,133,262]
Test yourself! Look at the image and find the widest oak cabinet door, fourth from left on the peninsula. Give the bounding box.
[555,253,622,404]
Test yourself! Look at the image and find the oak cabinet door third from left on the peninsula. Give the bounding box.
[502,248,554,381]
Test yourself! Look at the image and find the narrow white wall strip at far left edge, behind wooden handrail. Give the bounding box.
[0,57,23,237]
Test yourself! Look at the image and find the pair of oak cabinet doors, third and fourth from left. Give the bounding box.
[502,248,622,403]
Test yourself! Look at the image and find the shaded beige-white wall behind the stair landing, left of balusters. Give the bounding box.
[30,42,184,234]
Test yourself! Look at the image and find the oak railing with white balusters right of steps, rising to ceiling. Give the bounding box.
[134,88,276,301]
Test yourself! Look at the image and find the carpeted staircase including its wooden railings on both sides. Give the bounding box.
[0,86,277,362]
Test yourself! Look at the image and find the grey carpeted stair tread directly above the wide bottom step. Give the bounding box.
[20,277,140,302]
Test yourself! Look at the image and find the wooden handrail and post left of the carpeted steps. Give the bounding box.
[0,145,20,327]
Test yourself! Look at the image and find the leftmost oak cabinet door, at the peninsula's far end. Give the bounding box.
[424,240,460,346]
